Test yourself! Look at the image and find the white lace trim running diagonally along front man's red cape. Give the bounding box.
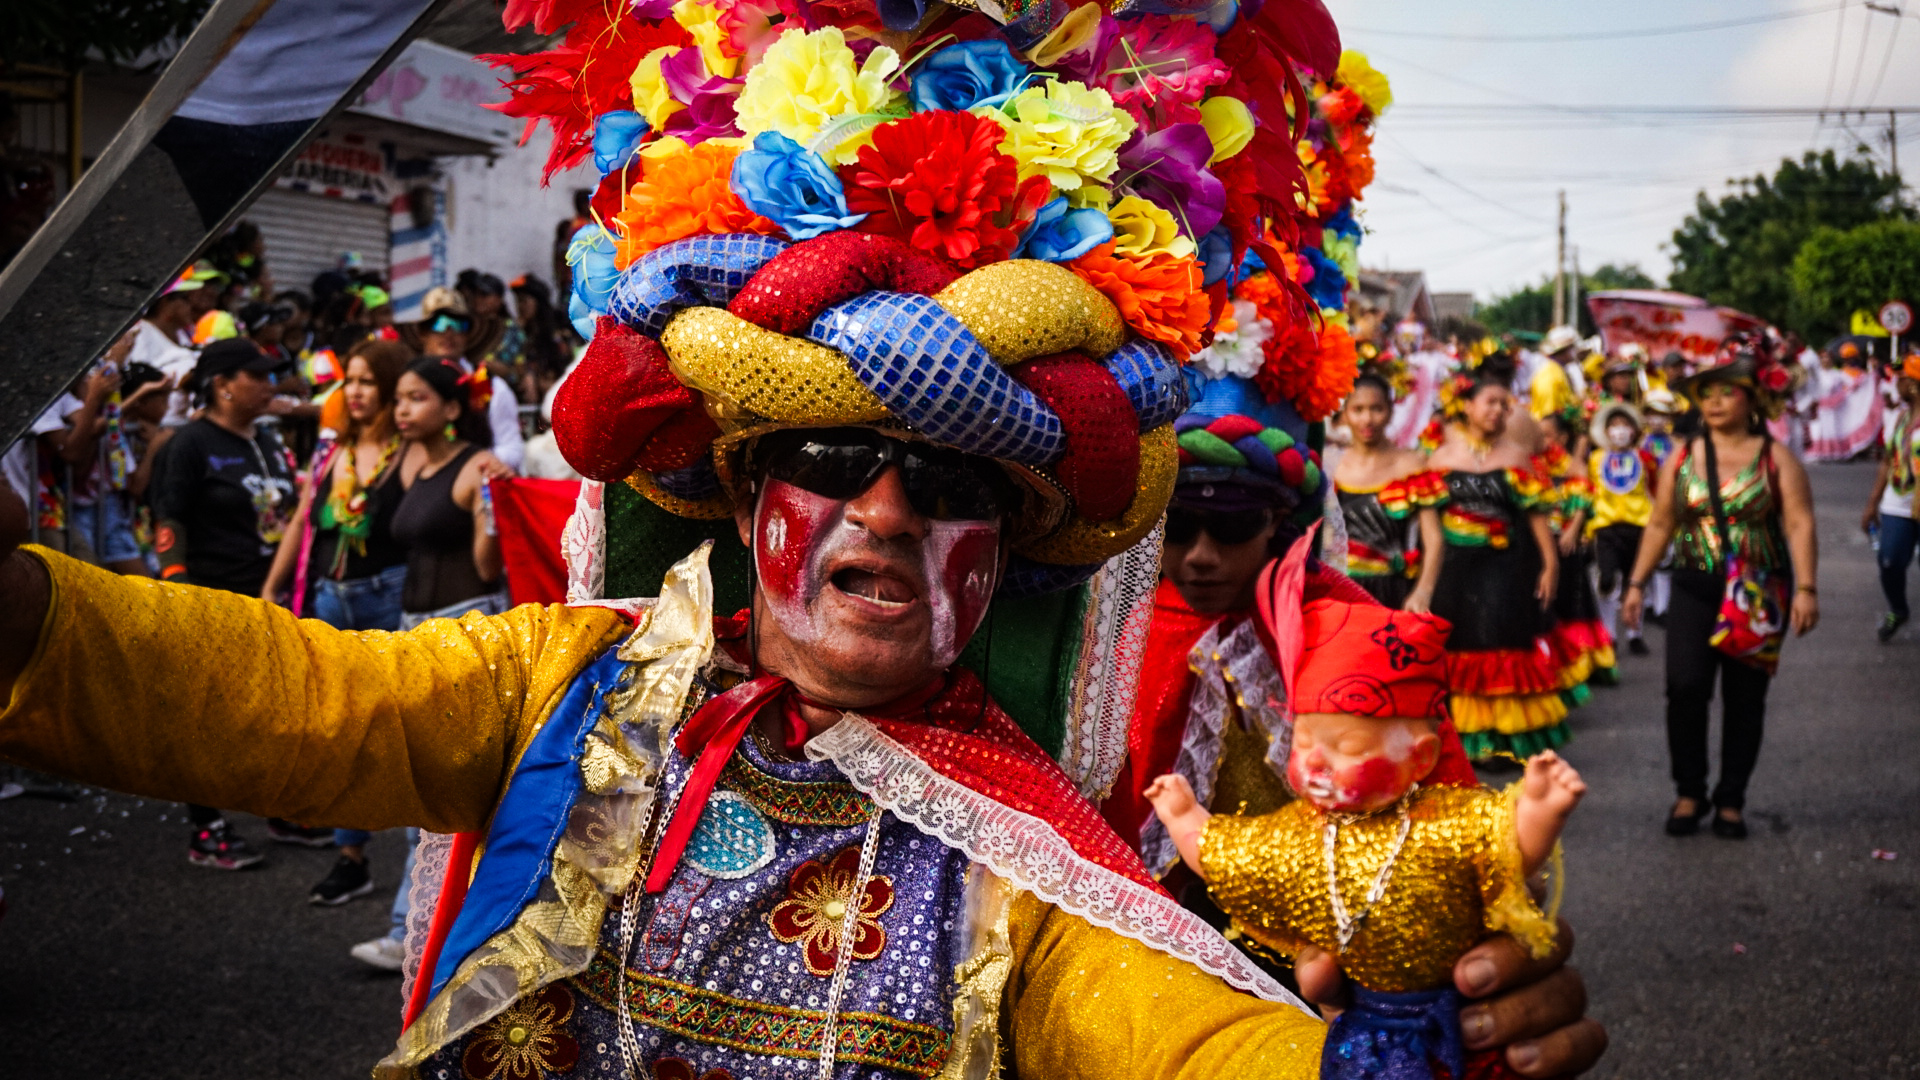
[806,713,1313,1015]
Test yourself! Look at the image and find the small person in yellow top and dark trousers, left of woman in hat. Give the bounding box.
[1586,399,1665,655]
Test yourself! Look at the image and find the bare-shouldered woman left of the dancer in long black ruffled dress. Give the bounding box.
[1332,375,1446,611]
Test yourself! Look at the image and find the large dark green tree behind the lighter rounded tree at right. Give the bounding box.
[1672,150,1914,332]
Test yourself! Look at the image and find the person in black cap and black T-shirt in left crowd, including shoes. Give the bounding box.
[148,338,297,871]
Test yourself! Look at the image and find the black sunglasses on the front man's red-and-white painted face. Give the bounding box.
[755,427,1018,521]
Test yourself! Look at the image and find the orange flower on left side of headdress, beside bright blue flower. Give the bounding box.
[612,142,780,269]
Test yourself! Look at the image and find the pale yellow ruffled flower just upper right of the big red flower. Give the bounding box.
[983,79,1135,192]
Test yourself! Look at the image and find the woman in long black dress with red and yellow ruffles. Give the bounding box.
[1428,354,1567,761]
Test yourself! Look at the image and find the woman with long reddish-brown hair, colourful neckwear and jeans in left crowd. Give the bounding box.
[261,338,415,630]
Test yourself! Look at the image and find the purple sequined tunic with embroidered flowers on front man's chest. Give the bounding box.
[419,722,968,1080]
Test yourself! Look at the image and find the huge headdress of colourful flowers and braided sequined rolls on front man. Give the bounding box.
[490,0,1344,590]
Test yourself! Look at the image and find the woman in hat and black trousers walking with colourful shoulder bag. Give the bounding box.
[1620,352,1820,840]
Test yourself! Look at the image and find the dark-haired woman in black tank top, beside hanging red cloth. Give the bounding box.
[394,357,513,628]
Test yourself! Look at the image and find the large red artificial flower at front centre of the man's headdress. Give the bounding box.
[841,110,1050,269]
